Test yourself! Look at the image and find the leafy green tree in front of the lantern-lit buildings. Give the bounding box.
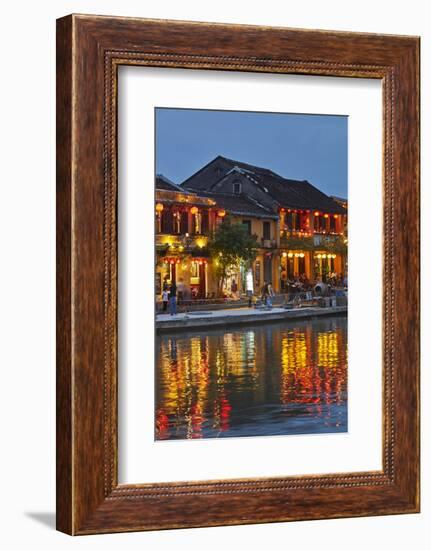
[208,219,258,295]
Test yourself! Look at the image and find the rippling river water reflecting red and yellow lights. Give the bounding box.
[155,317,347,440]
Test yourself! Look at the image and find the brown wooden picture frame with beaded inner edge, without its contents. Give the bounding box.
[57,15,419,534]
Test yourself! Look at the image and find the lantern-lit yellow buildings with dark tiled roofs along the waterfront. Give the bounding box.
[155,156,347,299]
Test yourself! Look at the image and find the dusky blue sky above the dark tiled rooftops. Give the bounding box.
[156,108,347,198]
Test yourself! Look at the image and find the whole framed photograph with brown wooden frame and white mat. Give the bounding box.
[57,15,419,535]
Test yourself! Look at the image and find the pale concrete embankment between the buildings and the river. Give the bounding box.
[156,306,347,332]
